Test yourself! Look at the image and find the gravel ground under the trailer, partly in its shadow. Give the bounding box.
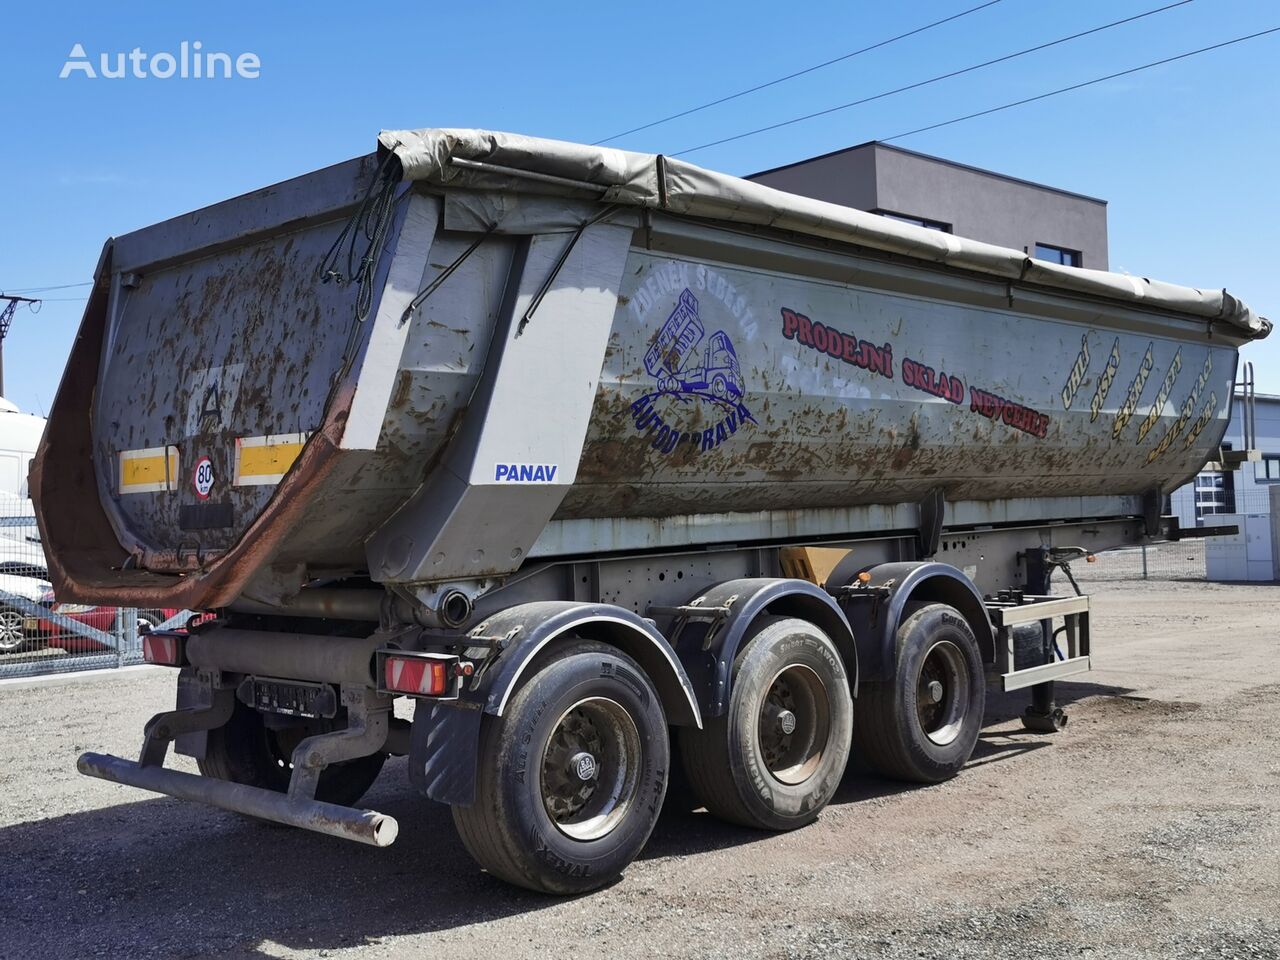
[0,582,1280,960]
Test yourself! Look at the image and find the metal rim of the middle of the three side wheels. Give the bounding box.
[759,663,831,786]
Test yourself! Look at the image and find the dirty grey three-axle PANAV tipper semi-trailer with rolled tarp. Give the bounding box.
[31,129,1271,893]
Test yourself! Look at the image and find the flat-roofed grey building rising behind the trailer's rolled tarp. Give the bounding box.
[748,141,1107,270]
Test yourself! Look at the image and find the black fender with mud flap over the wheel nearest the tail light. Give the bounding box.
[410,600,703,805]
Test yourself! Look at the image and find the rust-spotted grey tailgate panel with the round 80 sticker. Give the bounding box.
[93,215,355,549]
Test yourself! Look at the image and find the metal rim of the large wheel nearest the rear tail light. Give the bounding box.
[540,696,641,841]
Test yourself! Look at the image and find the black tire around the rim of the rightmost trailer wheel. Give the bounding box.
[854,603,987,783]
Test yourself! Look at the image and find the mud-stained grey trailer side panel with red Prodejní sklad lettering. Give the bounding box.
[557,252,1235,518]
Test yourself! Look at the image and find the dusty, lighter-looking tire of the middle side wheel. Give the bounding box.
[680,617,854,831]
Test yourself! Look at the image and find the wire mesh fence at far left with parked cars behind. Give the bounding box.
[0,506,191,678]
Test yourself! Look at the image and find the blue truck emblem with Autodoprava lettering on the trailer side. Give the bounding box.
[631,287,755,454]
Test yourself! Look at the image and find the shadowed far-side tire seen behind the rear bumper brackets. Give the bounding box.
[196,700,387,806]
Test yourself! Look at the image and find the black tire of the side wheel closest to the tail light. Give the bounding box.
[452,641,671,895]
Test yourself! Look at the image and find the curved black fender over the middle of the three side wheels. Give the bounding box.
[676,577,859,717]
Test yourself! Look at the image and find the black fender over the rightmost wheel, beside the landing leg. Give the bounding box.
[841,561,996,681]
